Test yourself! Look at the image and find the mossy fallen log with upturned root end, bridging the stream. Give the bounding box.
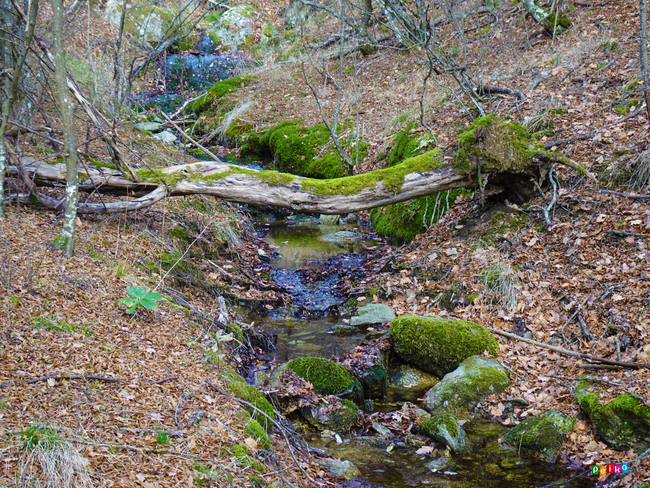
[8,116,584,214]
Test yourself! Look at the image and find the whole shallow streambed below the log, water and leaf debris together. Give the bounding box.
[233,217,594,488]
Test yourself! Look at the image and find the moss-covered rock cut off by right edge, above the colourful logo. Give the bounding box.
[574,377,650,452]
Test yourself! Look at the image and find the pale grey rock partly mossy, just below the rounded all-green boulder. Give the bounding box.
[424,356,510,416]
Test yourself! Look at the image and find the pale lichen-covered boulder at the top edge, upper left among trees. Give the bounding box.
[104,0,191,45]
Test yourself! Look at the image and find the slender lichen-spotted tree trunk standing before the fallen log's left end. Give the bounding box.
[52,0,79,255]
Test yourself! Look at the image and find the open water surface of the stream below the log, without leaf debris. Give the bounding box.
[243,217,594,488]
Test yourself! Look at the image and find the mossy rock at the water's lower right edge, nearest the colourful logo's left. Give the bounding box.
[503,410,576,463]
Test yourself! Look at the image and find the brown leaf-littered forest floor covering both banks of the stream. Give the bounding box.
[0,0,650,487]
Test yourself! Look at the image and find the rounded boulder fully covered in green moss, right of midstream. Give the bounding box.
[389,315,499,377]
